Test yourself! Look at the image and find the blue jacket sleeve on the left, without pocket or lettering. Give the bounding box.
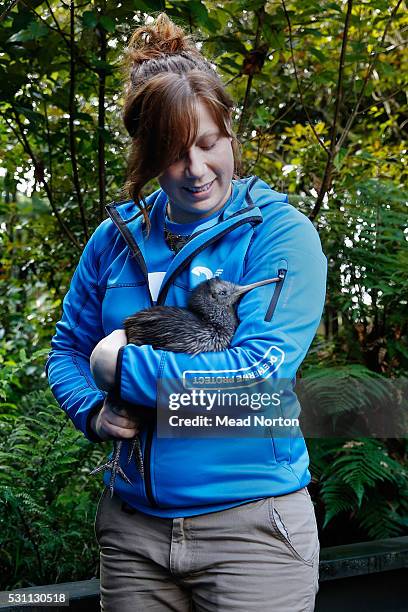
[45,230,106,442]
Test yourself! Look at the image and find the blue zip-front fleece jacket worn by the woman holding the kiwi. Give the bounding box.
[46,176,327,517]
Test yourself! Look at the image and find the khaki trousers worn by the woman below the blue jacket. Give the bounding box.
[95,487,320,612]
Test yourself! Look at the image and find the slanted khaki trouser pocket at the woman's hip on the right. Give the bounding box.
[268,487,320,566]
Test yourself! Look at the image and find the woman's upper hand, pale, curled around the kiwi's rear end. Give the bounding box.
[90,329,127,391]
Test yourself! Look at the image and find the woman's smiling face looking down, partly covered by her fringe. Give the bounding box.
[158,102,234,223]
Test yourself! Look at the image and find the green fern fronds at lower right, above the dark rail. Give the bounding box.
[297,356,408,540]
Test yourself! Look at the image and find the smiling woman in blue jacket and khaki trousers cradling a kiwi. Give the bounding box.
[47,14,326,612]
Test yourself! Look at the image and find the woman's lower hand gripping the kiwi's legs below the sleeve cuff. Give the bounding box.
[91,395,140,440]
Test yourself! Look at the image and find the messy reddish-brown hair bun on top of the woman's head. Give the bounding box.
[126,13,199,65]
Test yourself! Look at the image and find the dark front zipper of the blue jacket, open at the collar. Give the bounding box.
[106,205,262,508]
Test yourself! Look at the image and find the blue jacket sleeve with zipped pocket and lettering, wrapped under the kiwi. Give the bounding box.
[115,202,327,407]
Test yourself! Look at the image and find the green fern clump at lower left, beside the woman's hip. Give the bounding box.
[0,388,107,590]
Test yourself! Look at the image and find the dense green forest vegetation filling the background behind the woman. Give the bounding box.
[0,0,408,589]
